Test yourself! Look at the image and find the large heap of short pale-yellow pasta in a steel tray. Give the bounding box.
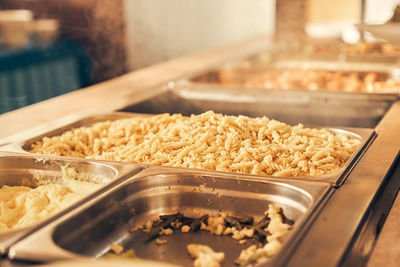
[31,111,360,177]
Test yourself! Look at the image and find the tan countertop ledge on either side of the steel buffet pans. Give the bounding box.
[0,38,400,266]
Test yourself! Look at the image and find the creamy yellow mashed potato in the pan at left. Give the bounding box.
[0,178,100,233]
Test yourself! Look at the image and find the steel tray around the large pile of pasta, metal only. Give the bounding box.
[2,113,375,186]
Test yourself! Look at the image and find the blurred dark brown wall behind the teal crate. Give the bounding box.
[0,0,127,82]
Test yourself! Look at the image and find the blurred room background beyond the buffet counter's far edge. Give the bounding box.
[0,0,398,113]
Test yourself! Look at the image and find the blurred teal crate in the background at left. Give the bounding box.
[0,41,90,113]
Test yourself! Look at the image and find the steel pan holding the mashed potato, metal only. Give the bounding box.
[0,153,141,254]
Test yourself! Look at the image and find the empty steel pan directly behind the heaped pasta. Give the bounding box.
[121,82,397,128]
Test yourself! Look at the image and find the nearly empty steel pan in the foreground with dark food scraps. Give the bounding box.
[9,167,332,266]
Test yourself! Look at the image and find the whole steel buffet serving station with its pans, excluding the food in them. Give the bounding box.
[0,38,400,266]
